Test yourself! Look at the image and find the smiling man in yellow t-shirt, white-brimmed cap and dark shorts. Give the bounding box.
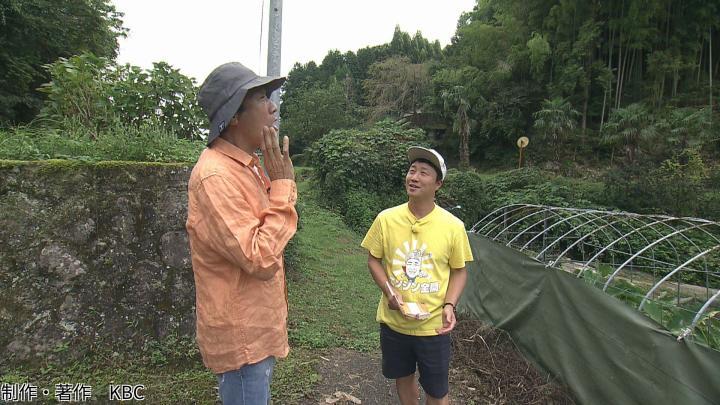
[361,147,473,405]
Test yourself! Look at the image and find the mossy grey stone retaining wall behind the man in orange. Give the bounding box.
[0,161,195,364]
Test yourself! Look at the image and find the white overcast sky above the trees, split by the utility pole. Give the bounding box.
[113,0,475,84]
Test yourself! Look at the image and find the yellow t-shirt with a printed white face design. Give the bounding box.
[360,203,473,336]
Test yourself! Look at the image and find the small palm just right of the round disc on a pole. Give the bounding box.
[533,97,580,163]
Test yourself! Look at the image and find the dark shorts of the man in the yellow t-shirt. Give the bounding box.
[380,323,452,398]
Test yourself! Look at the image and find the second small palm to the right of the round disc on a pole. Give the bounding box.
[602,103,657,164]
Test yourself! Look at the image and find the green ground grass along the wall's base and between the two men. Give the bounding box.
[0,168,380,404]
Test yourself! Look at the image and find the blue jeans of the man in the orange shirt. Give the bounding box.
[217,356,275,405]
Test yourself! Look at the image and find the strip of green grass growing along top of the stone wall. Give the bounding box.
[0,123,205,162]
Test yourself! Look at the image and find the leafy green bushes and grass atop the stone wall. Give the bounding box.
[0,53,207,162]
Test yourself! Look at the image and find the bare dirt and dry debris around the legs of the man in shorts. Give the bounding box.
[299,320,574,405]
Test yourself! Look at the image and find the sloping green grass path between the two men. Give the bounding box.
[288,174,380,351]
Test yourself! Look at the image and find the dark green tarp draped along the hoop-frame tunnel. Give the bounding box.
[460,233,720,405]
